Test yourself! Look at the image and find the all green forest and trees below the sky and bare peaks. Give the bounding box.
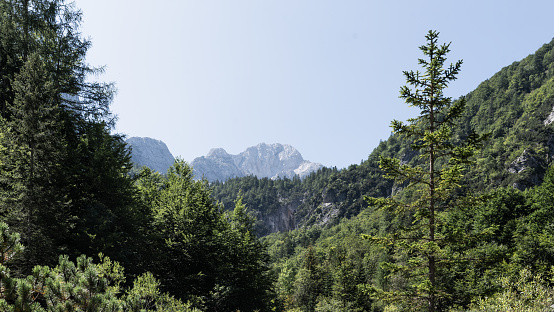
[0,0,554,312]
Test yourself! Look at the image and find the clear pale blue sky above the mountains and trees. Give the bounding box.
[75,0,554,169]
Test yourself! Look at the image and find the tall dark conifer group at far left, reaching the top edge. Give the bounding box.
[0,0,137,269]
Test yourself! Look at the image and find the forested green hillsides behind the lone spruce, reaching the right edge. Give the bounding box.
[213,34,554,311]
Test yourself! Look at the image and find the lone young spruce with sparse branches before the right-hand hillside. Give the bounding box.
[365,31,483,312]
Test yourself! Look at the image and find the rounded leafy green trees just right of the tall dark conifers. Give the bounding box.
[137,160,272,311]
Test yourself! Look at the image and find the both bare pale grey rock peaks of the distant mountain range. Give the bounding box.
[126,137,323,182]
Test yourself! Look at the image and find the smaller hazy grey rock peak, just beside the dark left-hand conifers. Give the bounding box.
[125,137,175,173]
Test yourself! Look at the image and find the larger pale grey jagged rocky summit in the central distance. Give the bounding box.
[191,143,323,181]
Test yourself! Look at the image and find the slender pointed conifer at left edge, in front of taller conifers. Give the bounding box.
[1,53,64,270]
